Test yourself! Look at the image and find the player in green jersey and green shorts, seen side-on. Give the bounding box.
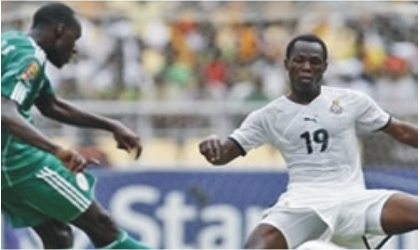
[1,3,152,249]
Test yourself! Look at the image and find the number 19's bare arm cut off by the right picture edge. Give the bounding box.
[383,117,418,148]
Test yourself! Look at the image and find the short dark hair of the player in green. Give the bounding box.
[32,3,78,28]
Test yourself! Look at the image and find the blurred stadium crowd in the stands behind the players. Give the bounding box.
[2,1,418,102]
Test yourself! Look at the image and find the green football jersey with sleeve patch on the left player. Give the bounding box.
[1,31,56,188]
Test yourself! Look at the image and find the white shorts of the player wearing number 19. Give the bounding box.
[260,190,396,249]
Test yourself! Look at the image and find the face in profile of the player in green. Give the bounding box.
[47,23,82,68]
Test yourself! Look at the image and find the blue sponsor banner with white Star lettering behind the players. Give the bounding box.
[2,169,418,249]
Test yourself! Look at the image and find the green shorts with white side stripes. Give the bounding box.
[1,165,95,228]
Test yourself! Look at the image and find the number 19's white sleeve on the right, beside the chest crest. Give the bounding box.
[356,93,391,131]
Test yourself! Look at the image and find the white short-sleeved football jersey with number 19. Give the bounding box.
[229,86,390,193]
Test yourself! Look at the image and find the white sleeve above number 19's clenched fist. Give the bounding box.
[229,110,268,153]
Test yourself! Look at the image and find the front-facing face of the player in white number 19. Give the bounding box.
[285,41,327,93]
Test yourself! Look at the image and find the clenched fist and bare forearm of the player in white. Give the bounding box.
[199,135,241,165]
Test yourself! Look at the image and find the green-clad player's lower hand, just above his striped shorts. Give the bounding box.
[55,149,99,173]
